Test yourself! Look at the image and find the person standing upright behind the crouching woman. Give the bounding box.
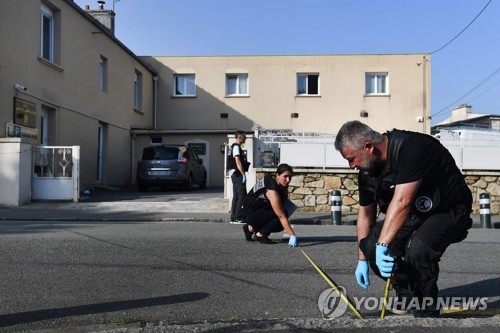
[228,131,250,224]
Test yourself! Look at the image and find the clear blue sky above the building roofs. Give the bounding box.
[74,0,500,125]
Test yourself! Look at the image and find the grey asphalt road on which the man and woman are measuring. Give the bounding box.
[0,221,500,332]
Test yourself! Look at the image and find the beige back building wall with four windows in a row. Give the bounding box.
[143,54,430,134]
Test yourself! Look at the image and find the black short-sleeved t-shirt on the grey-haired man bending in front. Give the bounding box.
[359,130,471,212]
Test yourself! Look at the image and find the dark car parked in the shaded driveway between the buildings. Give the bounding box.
[137,145,207,192]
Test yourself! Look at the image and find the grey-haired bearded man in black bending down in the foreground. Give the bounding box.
[335,121,472,317]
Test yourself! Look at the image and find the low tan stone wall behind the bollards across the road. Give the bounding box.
[257,169,500,215]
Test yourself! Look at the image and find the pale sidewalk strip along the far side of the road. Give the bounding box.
[0,187,500,228]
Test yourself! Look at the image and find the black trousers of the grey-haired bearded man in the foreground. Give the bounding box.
[359,213,472,310]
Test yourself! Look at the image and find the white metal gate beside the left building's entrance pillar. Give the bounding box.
[31,146,80,202]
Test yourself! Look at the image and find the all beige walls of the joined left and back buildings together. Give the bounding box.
[0,0,430,193]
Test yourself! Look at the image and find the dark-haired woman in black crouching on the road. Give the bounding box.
[242,164,298,247]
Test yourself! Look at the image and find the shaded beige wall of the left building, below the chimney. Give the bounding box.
[0,0,155,188]
